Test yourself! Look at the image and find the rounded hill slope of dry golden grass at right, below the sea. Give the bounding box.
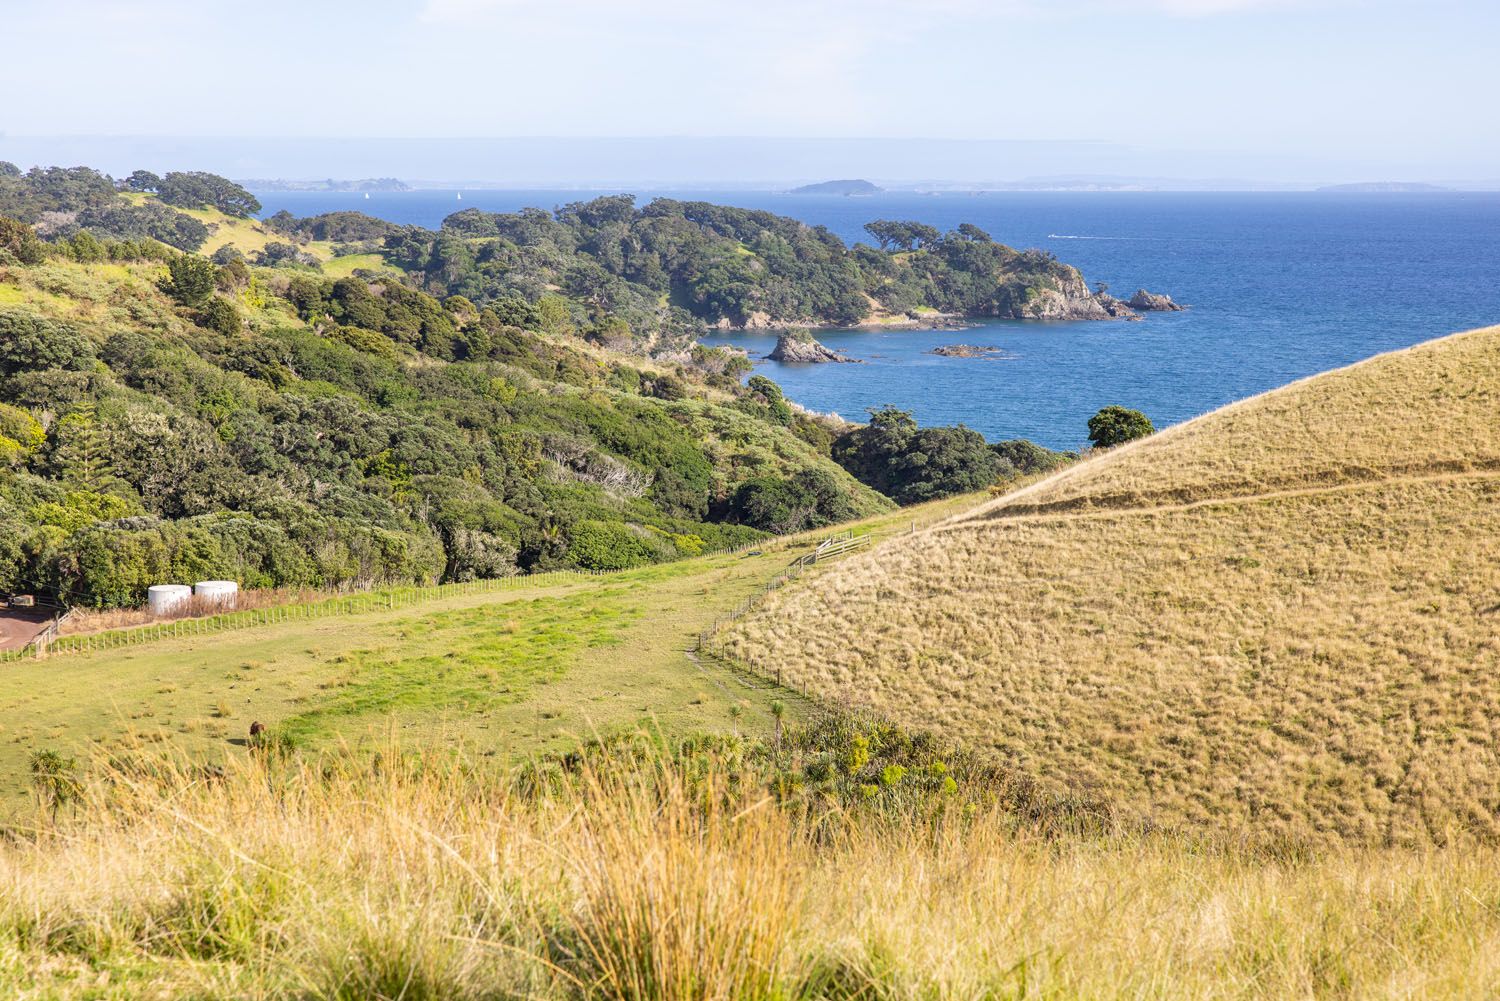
[722,327,1500,845]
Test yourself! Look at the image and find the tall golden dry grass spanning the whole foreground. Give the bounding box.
[11,749,1500,1001]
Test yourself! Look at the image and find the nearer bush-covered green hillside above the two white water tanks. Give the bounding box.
[0,229,885,605]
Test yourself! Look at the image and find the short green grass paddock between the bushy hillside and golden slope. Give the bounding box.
[0,497,981,816]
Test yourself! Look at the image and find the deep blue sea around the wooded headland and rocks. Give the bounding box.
[258,191,1500,449]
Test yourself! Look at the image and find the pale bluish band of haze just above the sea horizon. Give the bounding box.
[0,132,1500,191]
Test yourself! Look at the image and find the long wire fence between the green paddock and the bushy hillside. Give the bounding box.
[0,539,774,663]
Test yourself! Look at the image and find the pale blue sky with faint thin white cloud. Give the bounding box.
[0,0,1500,180]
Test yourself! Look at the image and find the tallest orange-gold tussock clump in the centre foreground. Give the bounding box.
[554,764,801,1001]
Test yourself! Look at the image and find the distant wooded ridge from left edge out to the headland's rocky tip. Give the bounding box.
[0,164,1131,350]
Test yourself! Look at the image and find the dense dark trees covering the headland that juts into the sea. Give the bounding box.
[367,195,1077,351]
